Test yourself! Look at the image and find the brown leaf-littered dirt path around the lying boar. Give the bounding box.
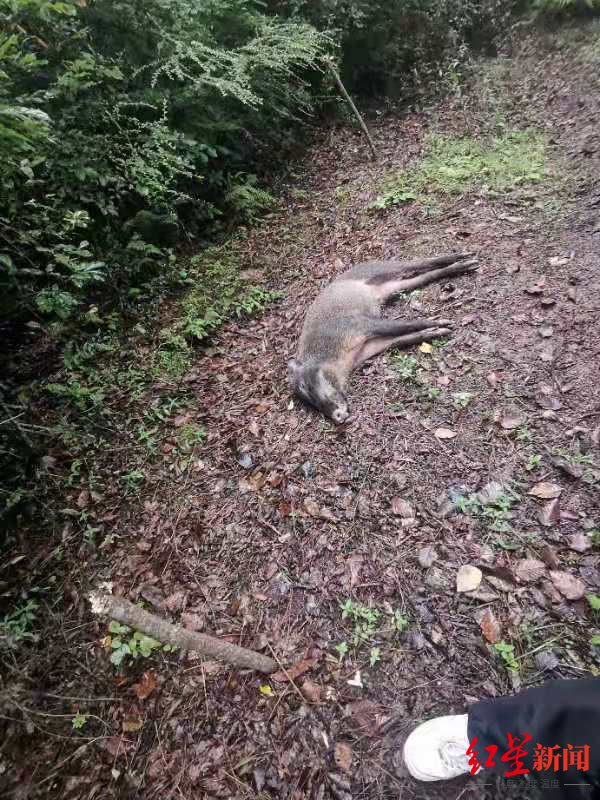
[4,20,600,800]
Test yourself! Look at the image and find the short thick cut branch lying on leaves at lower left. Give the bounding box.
[89,592,278,673]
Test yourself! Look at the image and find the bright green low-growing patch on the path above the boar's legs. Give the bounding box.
[369,131,547,209]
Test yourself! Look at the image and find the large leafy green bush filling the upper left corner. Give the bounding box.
[0,0,326,332]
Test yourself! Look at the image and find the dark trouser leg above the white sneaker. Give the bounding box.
[468,678,600,800]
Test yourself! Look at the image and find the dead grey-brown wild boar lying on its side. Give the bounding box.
[288,253,478,424]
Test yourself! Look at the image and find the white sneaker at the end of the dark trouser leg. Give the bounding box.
[404,714,471,781]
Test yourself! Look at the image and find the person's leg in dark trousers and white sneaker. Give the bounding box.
[404,678,600,797]
